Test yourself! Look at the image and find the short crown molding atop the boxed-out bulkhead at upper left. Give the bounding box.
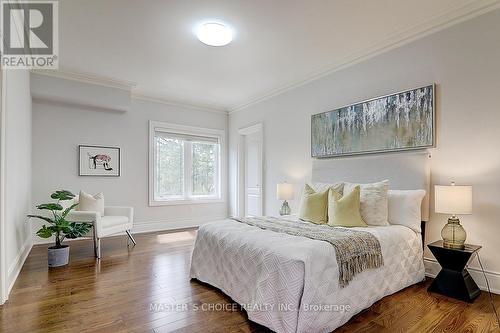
[31,69,137,91]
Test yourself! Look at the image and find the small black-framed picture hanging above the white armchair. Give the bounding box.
[78,145,120,177]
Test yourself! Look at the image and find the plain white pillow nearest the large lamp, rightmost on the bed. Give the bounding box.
[388,190,426,232]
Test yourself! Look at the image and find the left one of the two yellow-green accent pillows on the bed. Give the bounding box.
[299,184,329,224]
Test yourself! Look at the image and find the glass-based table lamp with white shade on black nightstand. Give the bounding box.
[434,183,472,249]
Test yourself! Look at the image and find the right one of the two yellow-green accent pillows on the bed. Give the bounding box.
[328,185,367,227]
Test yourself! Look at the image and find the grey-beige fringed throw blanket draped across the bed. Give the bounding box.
[233,216,384,288]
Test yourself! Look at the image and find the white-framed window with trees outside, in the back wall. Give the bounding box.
[149,122,224,206]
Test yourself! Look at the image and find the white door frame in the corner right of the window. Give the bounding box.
[236,123,265,217]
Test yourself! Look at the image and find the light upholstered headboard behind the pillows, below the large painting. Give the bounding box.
[312,152,430,221]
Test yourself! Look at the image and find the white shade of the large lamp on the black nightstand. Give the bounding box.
[434,185,472,215]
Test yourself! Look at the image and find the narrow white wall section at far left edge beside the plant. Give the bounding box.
[3,70,32,293]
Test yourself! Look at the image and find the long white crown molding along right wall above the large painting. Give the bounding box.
[229,0,500,114]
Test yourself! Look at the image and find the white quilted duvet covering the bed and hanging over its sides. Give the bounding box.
[191,220,425,332]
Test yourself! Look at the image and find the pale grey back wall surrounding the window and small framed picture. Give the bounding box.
[32,74,227,242]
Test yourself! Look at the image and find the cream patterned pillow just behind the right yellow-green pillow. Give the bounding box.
[344,180,389,225]
